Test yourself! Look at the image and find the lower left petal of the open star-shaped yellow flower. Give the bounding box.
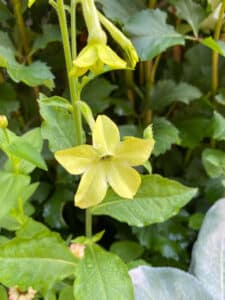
[74,164,108,208]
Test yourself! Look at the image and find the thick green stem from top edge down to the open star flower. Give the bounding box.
[57,0,83,145]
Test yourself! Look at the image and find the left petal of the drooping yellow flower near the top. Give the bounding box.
[73,45,98,68]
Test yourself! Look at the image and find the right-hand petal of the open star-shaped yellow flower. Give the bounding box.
[115,137,154,166]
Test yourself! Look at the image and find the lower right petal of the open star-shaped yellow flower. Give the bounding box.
[107,161,141,199]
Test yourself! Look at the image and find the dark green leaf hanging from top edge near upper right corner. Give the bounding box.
[170,0,206,37]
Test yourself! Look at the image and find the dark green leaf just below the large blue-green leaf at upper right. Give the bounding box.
[151,80,202,112]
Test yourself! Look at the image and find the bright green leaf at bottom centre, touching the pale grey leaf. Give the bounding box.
[74,244,134,300]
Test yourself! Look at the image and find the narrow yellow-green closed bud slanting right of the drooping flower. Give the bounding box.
[98,12,139,69]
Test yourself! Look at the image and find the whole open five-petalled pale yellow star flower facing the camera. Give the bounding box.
[55,115,154,208]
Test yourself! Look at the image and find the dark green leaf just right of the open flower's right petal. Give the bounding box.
[153,118,179,156]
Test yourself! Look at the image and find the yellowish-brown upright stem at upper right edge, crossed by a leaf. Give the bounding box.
[212,0,225,95]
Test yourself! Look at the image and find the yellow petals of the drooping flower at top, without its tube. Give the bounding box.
[70,42,127,76]
